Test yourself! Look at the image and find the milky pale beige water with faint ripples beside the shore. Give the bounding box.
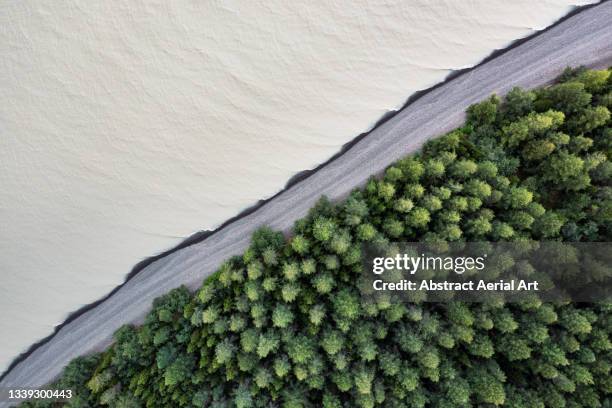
[0,0,588,370]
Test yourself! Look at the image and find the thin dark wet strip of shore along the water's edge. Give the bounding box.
[0,2,611,390]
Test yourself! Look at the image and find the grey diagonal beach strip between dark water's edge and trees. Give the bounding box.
[2,2,612,396]
